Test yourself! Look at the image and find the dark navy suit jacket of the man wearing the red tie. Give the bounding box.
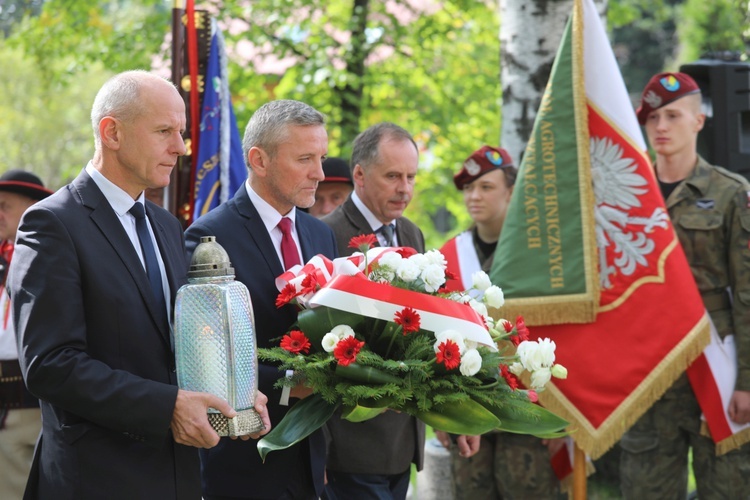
[186,185,336,499]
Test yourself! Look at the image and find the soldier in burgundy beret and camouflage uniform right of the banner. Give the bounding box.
[620,73,750,500]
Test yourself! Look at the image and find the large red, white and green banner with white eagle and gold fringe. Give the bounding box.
[491,0,709,458]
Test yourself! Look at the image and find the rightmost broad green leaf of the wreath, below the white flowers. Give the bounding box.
[480,400,569,438]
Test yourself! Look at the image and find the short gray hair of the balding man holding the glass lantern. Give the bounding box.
[91,69,173,149]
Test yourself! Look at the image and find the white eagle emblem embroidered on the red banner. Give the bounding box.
[591,137,668,289]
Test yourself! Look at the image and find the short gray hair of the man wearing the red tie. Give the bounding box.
[242,99,326,167]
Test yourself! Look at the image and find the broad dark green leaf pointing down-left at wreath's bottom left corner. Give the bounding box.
[258,394,338,462]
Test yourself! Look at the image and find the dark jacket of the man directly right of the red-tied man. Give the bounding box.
[322,195,425,474]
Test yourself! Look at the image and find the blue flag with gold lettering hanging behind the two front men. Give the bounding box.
[192,19,247,220]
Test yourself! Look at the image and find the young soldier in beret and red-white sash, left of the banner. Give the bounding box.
[437,146,562,500]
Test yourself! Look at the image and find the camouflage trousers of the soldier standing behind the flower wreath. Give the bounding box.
[451,432,565,500]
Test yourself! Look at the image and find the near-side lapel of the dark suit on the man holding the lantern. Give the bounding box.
[73,171,171,342]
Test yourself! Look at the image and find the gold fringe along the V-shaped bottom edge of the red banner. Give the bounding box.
[536,315,710,460]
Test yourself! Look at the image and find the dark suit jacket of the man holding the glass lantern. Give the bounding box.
[8,171,200,500]
